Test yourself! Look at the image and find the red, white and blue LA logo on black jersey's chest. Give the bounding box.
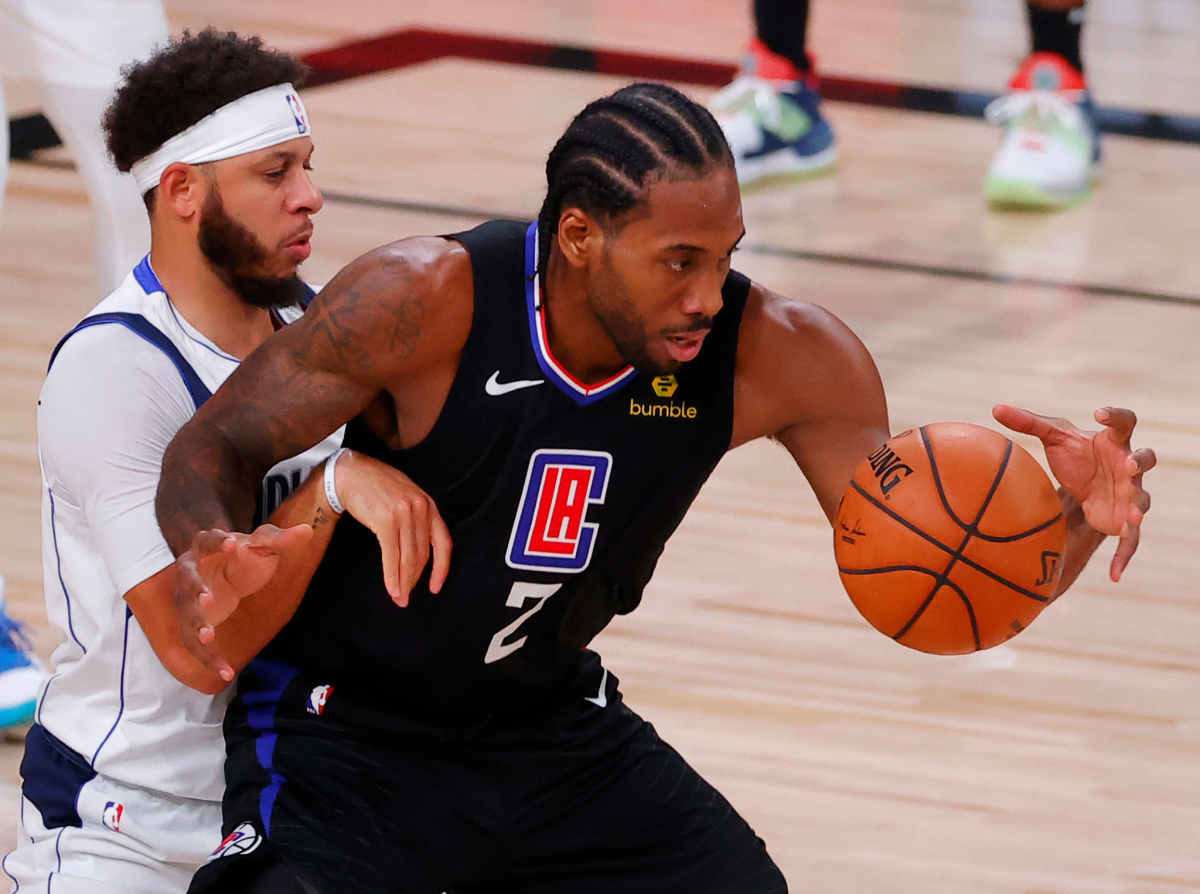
[505,450,612,574]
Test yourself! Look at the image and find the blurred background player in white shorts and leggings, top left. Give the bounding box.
[0,0,169,295]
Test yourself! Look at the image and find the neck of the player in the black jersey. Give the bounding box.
[541,246,629,385]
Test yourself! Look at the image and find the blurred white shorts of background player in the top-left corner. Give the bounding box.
[0,0,169,88]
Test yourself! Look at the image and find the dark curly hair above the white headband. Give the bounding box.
[103,28,308,172]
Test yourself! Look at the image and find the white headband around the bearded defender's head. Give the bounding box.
[130,84,312,194]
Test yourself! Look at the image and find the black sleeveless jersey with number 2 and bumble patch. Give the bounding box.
[264,221,749,716]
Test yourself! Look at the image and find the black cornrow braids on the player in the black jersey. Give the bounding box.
[538,83,733,275]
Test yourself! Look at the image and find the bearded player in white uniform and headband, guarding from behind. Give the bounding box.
[2,30,341,894]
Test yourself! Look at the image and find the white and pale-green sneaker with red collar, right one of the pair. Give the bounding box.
[984,53,1100,210]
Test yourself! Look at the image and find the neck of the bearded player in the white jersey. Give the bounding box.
[150,234,275,360]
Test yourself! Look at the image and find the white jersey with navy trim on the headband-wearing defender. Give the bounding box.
[36,258,342,802]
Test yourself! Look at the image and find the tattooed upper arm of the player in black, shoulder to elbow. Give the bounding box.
[156,250,426,556]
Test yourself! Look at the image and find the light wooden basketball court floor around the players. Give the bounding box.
[0,0,1200,894]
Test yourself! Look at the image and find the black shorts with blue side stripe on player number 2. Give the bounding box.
[190,661,787,894]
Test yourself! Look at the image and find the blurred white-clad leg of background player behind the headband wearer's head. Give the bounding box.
[39,84,150,295]
